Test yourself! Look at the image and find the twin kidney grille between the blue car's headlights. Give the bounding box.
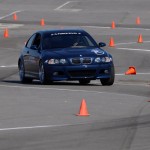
[70,57,92,65]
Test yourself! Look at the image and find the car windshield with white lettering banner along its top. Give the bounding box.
[43,33,97,50]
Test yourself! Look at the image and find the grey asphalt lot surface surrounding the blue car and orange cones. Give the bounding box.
[0,0,150,150]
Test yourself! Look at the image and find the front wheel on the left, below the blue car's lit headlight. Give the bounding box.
[39,62,51,85]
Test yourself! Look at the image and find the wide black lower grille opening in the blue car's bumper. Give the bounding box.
[69,70,96,77]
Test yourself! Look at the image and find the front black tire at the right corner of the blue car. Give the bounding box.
[100,66,115,86]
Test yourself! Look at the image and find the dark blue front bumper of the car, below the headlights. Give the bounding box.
[44,63,113,81]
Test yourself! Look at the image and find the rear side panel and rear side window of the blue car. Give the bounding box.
[23,34,36,75]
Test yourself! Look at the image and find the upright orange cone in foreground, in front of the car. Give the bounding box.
[77,99,90,116]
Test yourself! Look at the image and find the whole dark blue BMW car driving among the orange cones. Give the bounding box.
[18,29,115,85]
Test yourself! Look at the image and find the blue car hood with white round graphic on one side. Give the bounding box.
[44,48,107,58]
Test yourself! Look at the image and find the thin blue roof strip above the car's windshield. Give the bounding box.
[37,29,86,34]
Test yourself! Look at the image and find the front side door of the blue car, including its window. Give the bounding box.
[29,33,41,76]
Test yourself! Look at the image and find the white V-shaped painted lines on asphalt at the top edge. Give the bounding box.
[54,1,82,12]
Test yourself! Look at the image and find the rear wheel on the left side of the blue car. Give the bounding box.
[18,61,33,83]
